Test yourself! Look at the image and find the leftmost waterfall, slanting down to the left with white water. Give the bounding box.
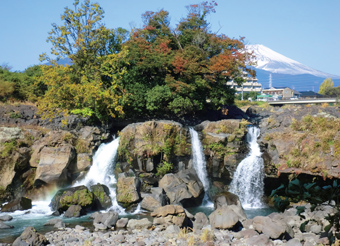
[73,138,124,213]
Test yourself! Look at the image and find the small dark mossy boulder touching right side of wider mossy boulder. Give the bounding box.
[90,184,112,210]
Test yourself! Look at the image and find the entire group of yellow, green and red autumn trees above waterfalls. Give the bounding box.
[7,0,252,122]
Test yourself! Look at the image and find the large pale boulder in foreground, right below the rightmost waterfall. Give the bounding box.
[253,216,294,239]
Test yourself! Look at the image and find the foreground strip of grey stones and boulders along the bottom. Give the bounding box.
[0,204,336,246]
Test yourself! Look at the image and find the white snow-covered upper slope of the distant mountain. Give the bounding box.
[246,44,337,78]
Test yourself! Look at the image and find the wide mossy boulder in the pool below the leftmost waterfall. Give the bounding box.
[51,185,94,213]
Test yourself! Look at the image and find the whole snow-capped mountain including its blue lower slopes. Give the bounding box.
[246,44,340,92]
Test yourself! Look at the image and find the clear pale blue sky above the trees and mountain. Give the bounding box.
[0,0,340,75]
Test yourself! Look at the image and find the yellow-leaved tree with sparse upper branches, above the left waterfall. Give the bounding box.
[36,0,127,122]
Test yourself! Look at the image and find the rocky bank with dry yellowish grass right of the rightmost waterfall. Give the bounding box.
[249,105,340,179]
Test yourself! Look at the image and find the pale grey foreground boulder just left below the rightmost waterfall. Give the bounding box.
[209,205,243,231]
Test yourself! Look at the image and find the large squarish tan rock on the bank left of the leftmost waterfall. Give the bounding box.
[34,144,76,186]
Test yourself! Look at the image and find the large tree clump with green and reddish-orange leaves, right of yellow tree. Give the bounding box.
[123,2,252,115]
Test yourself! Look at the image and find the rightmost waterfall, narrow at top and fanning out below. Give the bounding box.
[230,126,264,208]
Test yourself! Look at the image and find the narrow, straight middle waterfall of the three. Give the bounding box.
[189,127,213,206]
